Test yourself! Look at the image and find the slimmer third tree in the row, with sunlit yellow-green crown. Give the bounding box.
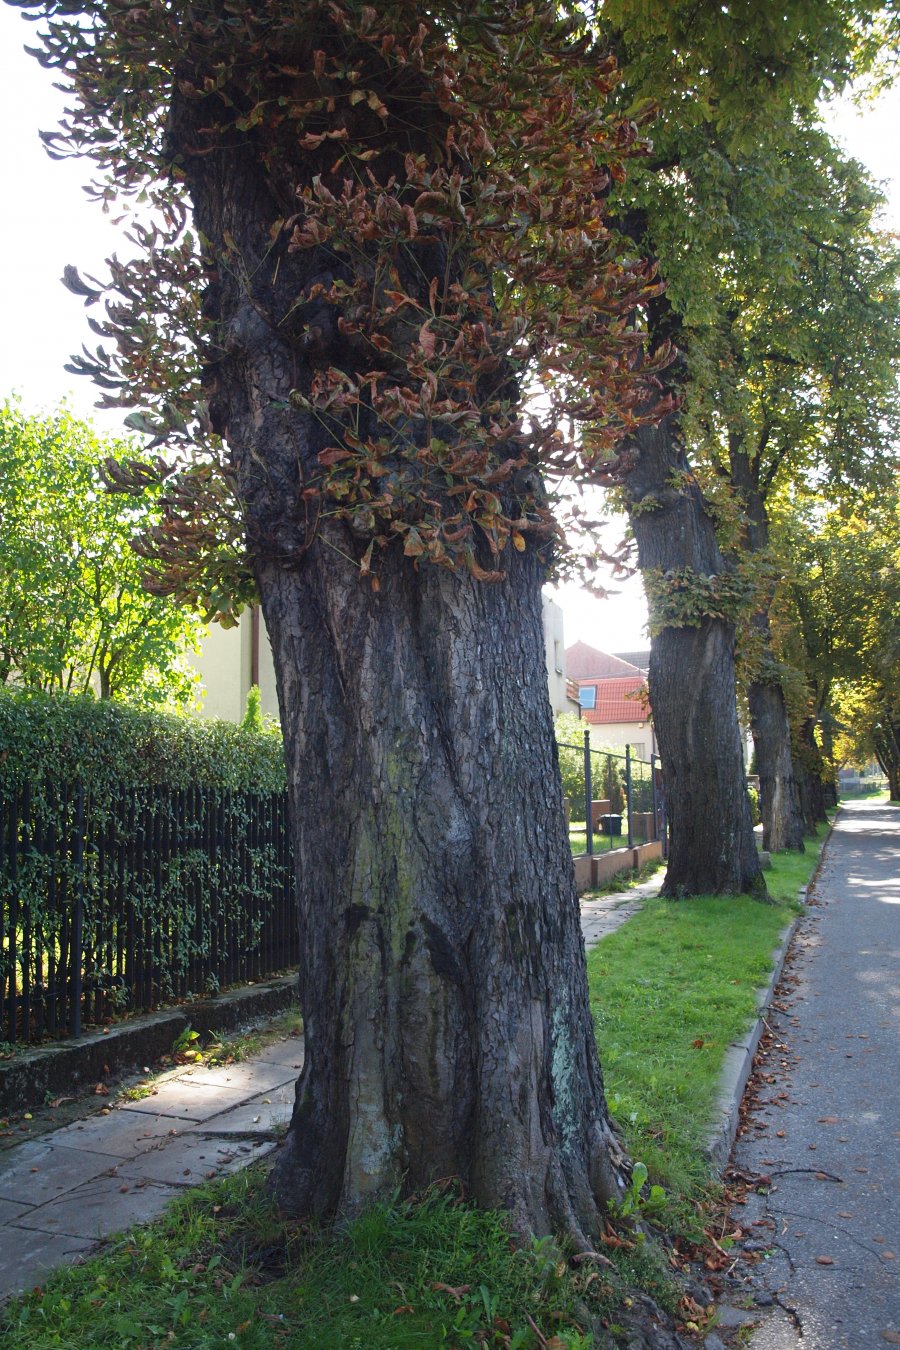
[690,127,900,849]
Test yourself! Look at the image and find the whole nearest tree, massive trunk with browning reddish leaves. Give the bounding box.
[8,0,682,1246]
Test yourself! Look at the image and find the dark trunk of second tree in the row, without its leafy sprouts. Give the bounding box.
[625,414,765,895]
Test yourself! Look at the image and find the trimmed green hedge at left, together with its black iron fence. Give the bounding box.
[0,690,288,1041]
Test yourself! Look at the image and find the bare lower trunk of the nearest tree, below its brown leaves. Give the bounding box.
[259,531,626,1245]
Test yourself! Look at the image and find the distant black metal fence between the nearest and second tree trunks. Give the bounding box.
[559,732,665,855]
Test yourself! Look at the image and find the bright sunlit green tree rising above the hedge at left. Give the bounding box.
[0,404,201,705]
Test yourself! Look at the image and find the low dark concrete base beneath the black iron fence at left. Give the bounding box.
[0,975,297,1115]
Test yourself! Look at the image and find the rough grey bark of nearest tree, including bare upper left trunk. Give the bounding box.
[170,10,621,1249]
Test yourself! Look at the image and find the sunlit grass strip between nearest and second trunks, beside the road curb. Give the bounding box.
[587,826,827,1200]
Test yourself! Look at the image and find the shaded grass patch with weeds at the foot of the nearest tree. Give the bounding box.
[0,1166,682,1350]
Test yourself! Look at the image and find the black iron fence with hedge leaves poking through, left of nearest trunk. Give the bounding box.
[0,783,300,1042]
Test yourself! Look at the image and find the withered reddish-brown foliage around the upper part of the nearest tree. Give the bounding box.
[7,0,680,621]
